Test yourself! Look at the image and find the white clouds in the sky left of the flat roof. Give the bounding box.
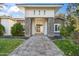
[0,4,23,17]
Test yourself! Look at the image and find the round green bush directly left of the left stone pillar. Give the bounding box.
[11,23,24,36]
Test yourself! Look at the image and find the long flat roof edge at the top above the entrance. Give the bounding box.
[16,3,64,7]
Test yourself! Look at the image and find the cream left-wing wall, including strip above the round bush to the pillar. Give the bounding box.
[1,18,25,35]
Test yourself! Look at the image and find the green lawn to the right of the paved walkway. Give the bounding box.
[53,40,79,56]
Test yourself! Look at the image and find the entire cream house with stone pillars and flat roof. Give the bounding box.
[1,3,63,37]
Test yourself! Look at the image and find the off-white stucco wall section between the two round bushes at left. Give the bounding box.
[1,19,16,35]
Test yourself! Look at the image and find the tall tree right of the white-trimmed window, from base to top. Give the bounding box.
[60,4,76,38]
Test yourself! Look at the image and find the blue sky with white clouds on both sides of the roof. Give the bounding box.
[0,3,68,18]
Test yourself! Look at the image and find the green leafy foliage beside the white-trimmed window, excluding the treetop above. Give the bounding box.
[60,16,76,38]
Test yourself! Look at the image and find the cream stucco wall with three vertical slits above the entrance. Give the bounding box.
[25,8,54,17]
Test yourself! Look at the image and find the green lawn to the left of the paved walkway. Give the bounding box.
[0,38,23,56]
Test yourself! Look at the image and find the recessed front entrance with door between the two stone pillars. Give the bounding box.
[32,18,47,35]
